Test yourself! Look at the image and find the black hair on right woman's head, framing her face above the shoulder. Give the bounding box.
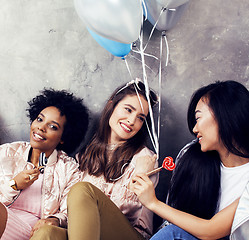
[188,80,249,158]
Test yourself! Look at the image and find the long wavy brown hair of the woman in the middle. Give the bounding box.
[79,83,156,182]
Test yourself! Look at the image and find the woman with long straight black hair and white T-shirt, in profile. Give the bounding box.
[131,81,249,240]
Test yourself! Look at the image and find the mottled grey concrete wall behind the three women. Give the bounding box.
[0,0,249,229]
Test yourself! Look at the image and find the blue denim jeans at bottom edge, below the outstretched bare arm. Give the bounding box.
[150,225,198,240]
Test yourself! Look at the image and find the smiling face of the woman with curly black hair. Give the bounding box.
[30,106,66,157]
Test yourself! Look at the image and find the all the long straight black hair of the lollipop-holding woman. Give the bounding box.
[168,80,249,219]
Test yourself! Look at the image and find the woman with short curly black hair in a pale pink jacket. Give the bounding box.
[0,89,88,240]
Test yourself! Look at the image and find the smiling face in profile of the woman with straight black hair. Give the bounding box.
[193,99,223,152]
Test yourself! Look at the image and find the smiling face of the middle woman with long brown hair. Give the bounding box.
[109,95,149,144]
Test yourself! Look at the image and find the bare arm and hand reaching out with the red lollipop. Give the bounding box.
[131,174,239,240]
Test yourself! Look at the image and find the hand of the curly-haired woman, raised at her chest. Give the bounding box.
[13,168,40,190]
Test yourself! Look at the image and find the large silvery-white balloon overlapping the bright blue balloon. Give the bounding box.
[74,0,143,43]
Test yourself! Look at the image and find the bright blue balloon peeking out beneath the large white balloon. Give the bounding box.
[87,28,132,57]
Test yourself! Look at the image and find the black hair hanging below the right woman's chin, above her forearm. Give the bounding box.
[168,143,220,219]
